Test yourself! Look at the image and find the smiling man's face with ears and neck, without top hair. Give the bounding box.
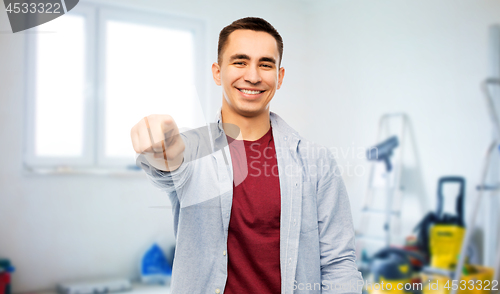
[212,24,285,137]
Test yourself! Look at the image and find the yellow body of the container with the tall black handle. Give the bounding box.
[430,224,465,270]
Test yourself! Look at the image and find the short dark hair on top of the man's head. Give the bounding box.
[217,17,283,66]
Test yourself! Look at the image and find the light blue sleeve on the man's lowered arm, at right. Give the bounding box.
[317,153,363,294]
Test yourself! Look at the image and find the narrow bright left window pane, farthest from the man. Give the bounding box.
[34,15,86,157]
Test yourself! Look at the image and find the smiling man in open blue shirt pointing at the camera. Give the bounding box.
[131,18,362,294]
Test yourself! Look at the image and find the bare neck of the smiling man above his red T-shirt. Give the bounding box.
[221,108,271,141]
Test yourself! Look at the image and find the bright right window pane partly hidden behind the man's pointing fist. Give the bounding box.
[104,21,199,157]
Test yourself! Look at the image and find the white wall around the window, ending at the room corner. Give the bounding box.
[0,0,306,292]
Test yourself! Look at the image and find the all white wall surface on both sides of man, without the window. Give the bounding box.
[0,0,500,292]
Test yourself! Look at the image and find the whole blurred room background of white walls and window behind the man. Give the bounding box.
[0,0,500,293]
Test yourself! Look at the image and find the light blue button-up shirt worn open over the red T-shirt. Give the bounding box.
[136,111,363,294]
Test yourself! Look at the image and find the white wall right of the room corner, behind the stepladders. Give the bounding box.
[307,0,500,253]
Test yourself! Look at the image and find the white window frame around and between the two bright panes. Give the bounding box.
[24,2,208,175]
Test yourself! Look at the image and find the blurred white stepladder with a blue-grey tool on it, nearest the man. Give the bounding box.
[356,113,425,260]
